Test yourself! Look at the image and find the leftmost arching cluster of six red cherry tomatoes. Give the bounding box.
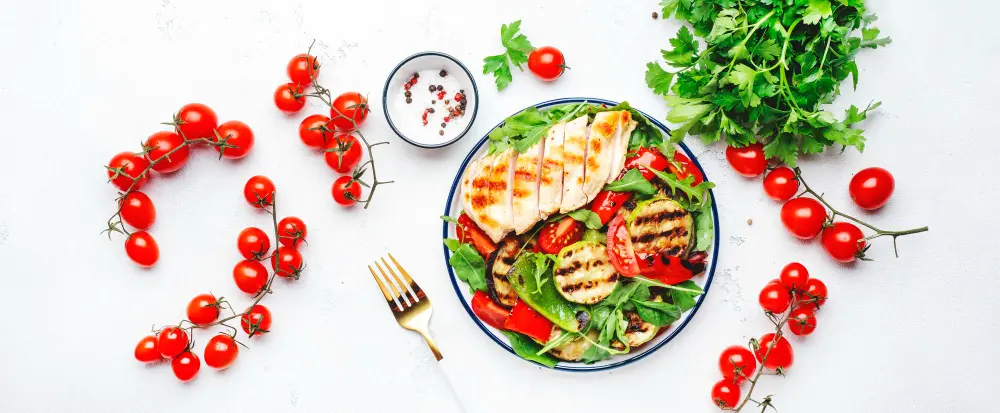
[107,103,254,267]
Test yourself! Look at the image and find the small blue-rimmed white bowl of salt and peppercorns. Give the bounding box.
[382,52,479,148]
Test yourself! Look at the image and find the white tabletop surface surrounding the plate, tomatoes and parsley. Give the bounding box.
[0,0,1000,412]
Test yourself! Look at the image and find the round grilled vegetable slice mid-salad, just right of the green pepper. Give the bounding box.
[553,241,618,304]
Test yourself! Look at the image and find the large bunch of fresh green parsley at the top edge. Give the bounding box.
[646,0,891,166]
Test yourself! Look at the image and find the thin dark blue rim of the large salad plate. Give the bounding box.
[441,97,719,372]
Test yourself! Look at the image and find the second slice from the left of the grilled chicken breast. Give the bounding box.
[511,139,545,234]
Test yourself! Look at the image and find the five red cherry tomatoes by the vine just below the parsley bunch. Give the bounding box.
[726,143,896,263]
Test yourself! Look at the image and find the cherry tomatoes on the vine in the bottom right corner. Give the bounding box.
[712,262,829,409]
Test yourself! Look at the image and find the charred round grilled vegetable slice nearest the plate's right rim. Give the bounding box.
[629,198,694,256]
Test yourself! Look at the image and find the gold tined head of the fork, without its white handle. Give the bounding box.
[368,254,444,361]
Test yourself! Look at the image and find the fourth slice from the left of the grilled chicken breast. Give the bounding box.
[559,115,588,213]
